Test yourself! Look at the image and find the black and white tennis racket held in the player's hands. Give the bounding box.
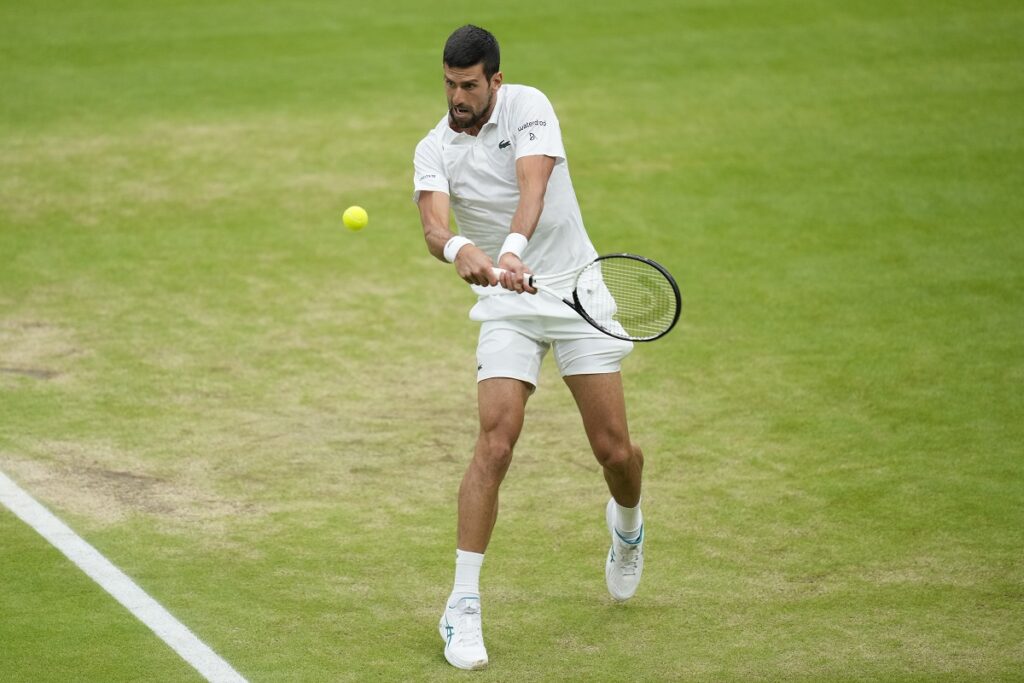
[495,254,683,341]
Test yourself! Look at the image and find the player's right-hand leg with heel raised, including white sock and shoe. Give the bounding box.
[564,372,643,600]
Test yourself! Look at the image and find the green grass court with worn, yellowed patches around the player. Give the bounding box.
[0,0,1024,681]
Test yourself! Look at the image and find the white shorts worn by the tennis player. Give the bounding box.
[476,317,633,387]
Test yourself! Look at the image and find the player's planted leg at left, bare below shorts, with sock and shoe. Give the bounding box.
[438,378,532,669]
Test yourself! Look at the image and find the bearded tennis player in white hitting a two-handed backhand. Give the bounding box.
[414,26,644,669]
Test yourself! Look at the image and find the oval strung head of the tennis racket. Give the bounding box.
[577,258,680,340]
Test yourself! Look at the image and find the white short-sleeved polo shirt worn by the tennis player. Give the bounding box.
[413,85,597,321]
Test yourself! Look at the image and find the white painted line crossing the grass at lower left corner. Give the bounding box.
[0,472,246,683]
